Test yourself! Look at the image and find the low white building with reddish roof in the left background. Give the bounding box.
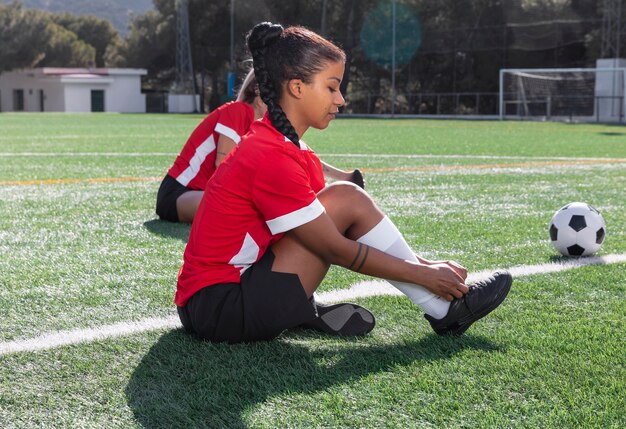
[0,67,147,113]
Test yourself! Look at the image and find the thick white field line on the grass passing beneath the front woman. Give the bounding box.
[0,254,626,356]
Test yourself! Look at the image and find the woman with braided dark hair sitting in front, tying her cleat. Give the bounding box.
[175,23,512,343]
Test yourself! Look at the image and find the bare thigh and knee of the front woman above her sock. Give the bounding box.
[272,182,384,297]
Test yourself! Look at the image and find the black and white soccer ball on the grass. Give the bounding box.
[549,203,606,256]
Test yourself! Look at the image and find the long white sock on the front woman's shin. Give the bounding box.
[357,216,450,319]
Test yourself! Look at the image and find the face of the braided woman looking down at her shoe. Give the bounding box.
[294,62,346,130]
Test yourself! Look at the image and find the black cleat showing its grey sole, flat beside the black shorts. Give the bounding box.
[300,298,376,337]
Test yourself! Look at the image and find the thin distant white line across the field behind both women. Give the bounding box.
[0,152,626,162]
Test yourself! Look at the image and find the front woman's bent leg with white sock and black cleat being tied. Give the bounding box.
[272,183,512,335]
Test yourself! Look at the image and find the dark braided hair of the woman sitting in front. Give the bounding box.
[247,22,346,145]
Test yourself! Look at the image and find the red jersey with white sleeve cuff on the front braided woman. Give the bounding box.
[175,115,325,306]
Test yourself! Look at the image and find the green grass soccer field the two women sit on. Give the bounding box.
[0,113,626,428]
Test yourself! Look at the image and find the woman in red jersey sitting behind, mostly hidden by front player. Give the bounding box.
[156,70,365,222]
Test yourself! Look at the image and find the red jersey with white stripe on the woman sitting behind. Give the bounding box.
[167,101,254,190]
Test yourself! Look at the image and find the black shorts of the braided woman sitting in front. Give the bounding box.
[178,249,316,343]
